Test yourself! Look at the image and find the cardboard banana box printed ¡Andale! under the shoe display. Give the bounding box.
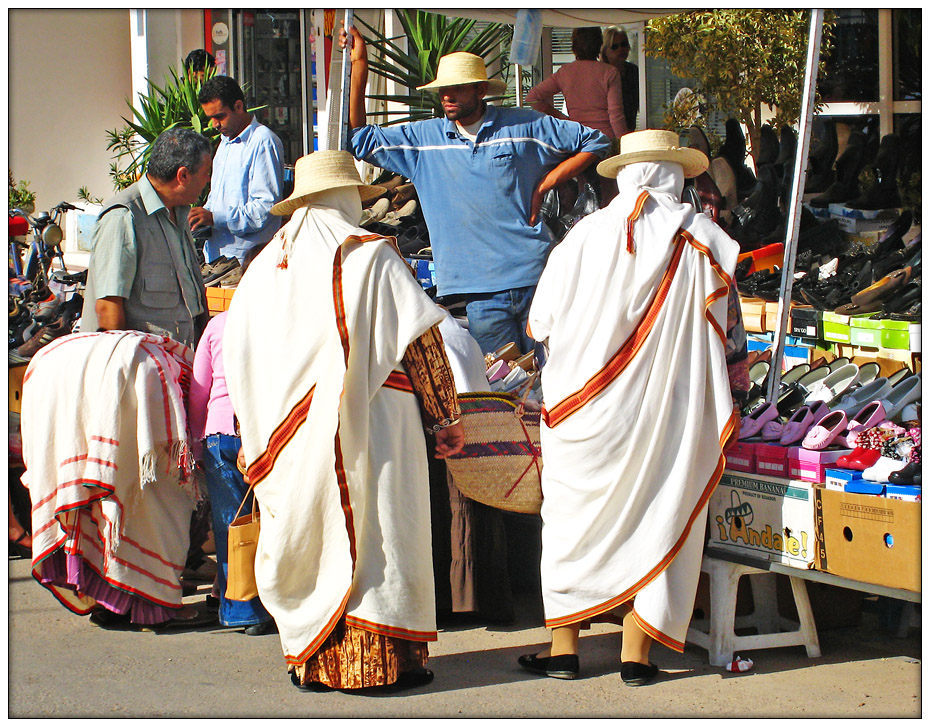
[708,472,816,568]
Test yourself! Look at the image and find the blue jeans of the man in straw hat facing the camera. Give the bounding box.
[465,286,536,353]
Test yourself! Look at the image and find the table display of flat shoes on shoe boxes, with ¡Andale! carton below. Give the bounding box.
[709,356,922,591]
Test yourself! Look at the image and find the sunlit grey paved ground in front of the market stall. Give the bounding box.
[8,559,921,718]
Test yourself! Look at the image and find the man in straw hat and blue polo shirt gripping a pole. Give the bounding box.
[341,28,610,353]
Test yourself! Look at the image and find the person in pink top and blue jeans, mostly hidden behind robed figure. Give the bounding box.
[187,312,275,636]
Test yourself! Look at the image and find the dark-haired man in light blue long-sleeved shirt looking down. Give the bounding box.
[189,76,284,266]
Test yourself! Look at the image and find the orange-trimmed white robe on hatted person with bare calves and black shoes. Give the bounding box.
[529,163,738,650]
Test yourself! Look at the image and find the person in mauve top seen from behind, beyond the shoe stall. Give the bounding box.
[526,27,629,207]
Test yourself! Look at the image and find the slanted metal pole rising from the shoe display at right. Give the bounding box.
[765,10,823,402]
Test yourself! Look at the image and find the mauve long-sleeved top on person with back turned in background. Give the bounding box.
[526,61,628,139]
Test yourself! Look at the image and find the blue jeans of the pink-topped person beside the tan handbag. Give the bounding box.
[203,434,271,626]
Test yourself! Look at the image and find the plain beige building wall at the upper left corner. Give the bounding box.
[8,9,131,210]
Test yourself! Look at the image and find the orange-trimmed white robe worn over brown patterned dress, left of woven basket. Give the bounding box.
[223,188,443,664]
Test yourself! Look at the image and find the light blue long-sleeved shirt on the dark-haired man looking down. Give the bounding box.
[204,116,284,262]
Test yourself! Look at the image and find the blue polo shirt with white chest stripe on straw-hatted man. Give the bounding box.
[350,105,610,295]
